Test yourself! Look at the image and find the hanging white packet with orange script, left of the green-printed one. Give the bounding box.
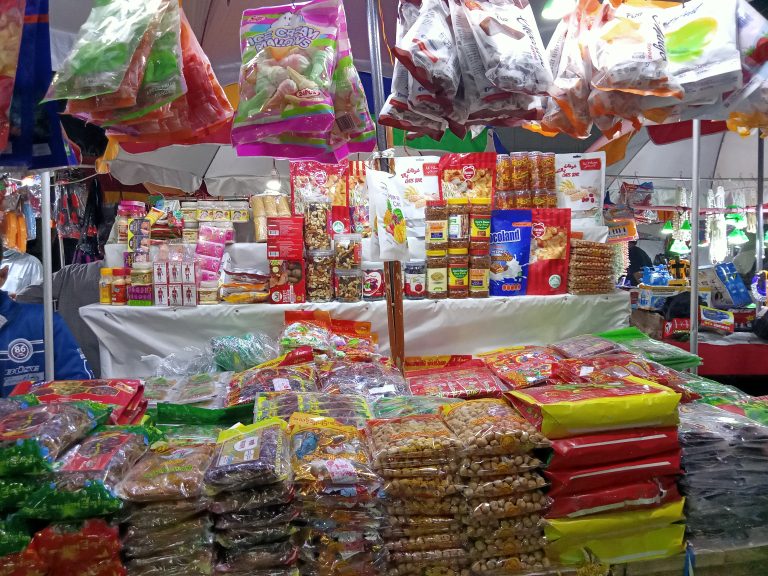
[588,0,683,98]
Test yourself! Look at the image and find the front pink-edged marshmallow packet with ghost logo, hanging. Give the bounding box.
[232,0,340,151]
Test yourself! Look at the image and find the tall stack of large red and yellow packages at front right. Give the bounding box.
[509,336,685,564]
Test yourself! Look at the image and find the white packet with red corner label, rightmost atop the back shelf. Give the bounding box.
[555,152,605,226]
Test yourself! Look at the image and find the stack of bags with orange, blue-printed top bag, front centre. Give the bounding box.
[289,412,386,576]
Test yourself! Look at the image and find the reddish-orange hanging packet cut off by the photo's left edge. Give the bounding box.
[0,0,25,150]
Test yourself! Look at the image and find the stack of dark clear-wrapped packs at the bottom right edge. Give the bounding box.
[680,403,768,549]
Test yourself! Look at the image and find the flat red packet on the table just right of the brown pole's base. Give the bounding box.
[406,360,507,399]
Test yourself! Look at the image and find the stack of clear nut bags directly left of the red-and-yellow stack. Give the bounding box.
[440,398,549,575]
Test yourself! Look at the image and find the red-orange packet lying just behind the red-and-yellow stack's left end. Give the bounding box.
[478,346,562,390]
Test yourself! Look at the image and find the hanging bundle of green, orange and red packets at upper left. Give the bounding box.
[46,0,233,146]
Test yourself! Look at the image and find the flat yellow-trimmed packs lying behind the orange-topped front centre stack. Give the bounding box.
[253,392,371,428]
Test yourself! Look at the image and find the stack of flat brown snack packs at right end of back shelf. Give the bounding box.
[568,239,616,294]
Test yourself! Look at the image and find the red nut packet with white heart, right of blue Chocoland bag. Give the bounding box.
[527,208,571,296]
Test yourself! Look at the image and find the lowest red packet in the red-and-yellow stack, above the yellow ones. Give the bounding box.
[547,476,681,518]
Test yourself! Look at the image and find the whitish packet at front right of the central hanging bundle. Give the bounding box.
[463,0,552,94]
